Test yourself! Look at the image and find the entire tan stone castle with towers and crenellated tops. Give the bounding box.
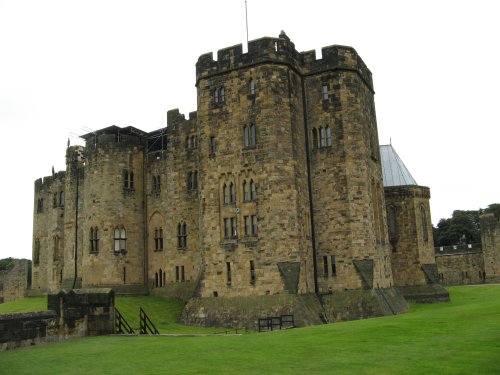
[32,32,448,325]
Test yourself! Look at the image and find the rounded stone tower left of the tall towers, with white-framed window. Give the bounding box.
[78,126,146,288]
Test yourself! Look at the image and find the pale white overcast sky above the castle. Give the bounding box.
[0,0,500,258]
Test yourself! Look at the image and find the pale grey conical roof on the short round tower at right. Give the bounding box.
[380,145,418,187]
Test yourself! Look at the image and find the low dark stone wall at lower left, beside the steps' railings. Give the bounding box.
[0,289,115,351]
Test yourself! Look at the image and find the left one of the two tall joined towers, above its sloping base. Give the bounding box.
[196,32,314,297]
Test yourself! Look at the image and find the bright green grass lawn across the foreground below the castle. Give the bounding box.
[0,285,500,375]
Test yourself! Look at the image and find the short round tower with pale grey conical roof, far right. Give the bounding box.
[380,145,449,302]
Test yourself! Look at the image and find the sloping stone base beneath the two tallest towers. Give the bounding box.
[180,288,408,329]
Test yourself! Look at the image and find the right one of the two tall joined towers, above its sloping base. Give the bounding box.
[303,46,392,293]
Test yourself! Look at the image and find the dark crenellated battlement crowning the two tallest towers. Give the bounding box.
[196,32,373,91]
